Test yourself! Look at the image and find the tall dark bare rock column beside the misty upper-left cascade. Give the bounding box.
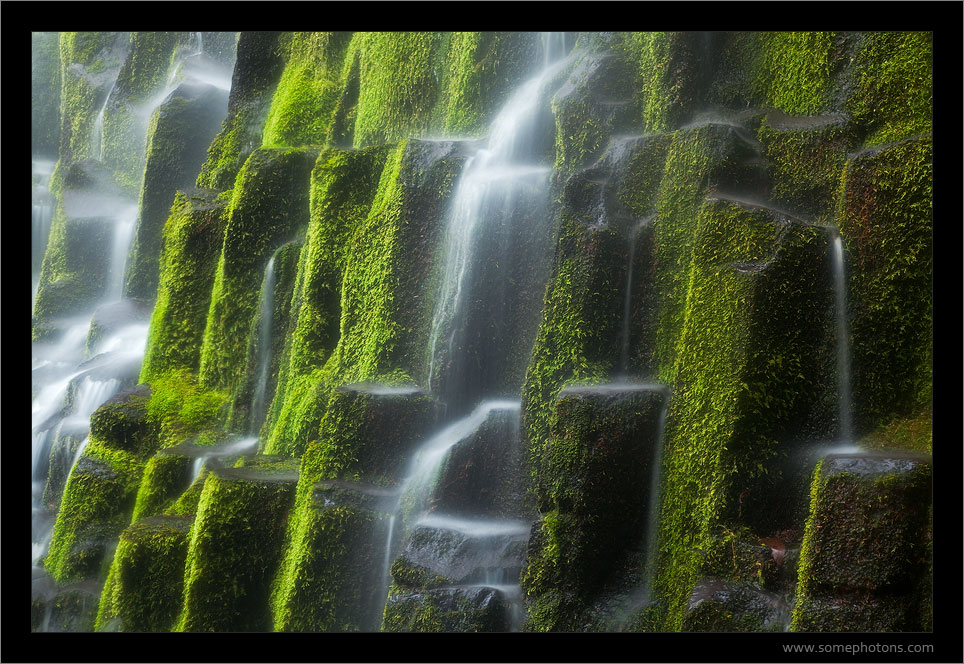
[124,83,227,300]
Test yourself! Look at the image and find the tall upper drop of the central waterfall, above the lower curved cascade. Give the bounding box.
[428,38,568,415]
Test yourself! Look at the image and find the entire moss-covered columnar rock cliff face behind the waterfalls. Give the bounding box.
[32,32,932,631]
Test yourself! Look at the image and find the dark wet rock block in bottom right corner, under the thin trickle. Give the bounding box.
[792,452,931,631]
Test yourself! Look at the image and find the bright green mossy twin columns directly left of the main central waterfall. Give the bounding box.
[265,142,460,454]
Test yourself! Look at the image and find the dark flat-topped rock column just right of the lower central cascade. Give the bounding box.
[522,384,666,631]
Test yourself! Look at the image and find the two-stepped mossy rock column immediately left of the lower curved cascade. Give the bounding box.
[272,384,435,631]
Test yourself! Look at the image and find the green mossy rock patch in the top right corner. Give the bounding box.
[847,32,934,145]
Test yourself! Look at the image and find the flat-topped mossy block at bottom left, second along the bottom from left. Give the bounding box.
[173,457,298,632]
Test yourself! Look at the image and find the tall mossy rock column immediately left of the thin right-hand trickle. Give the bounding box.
[659,199,836,629]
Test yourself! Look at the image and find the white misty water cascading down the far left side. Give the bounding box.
[31,33,231,629]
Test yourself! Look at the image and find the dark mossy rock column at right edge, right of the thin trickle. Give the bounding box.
[839,138,933,435]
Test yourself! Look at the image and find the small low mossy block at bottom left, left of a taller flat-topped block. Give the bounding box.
[95,517,192,632]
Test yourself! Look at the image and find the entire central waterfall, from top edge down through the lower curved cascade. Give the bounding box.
[384,33,567,630]
